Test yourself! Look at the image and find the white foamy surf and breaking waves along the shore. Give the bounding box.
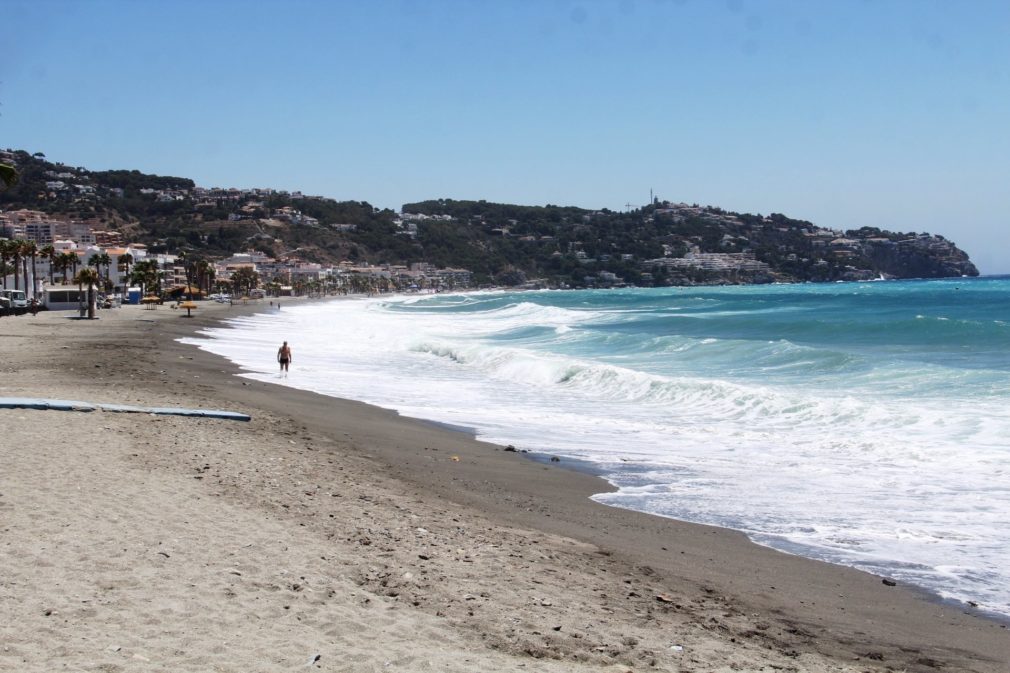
[181,284,1010,614]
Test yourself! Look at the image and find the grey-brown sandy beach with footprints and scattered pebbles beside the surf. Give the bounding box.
[0,302,1010,673]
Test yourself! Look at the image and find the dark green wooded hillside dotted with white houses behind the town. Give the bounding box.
[0,151,978,287]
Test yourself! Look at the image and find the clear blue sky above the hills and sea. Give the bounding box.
[0,0,1010,273]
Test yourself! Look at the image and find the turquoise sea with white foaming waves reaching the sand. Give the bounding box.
[185,277,1010,616]
